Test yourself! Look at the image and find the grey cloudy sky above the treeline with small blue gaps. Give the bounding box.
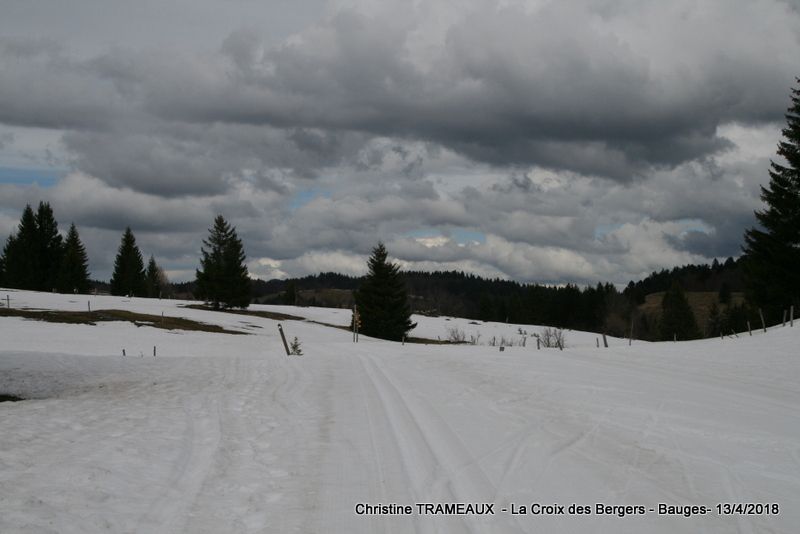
[0,0,800,284]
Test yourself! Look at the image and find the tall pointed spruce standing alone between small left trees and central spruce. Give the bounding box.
[196,215,251,309]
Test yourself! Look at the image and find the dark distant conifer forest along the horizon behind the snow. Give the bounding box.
[167,258,758,340]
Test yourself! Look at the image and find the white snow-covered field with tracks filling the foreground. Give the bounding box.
[0,290,800,534]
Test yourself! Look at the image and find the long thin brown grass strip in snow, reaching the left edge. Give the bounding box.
[0,308,246,334]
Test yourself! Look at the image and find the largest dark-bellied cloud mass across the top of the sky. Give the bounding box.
[119,2,798,181]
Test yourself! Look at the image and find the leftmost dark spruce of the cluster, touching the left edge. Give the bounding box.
[3,204,44,290]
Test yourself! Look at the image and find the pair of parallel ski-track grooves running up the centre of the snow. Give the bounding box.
[360,356,524,532]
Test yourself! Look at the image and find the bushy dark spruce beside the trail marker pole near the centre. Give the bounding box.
[355,243,417,341]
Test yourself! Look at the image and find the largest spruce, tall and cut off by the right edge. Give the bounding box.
[743,78,800,320]
